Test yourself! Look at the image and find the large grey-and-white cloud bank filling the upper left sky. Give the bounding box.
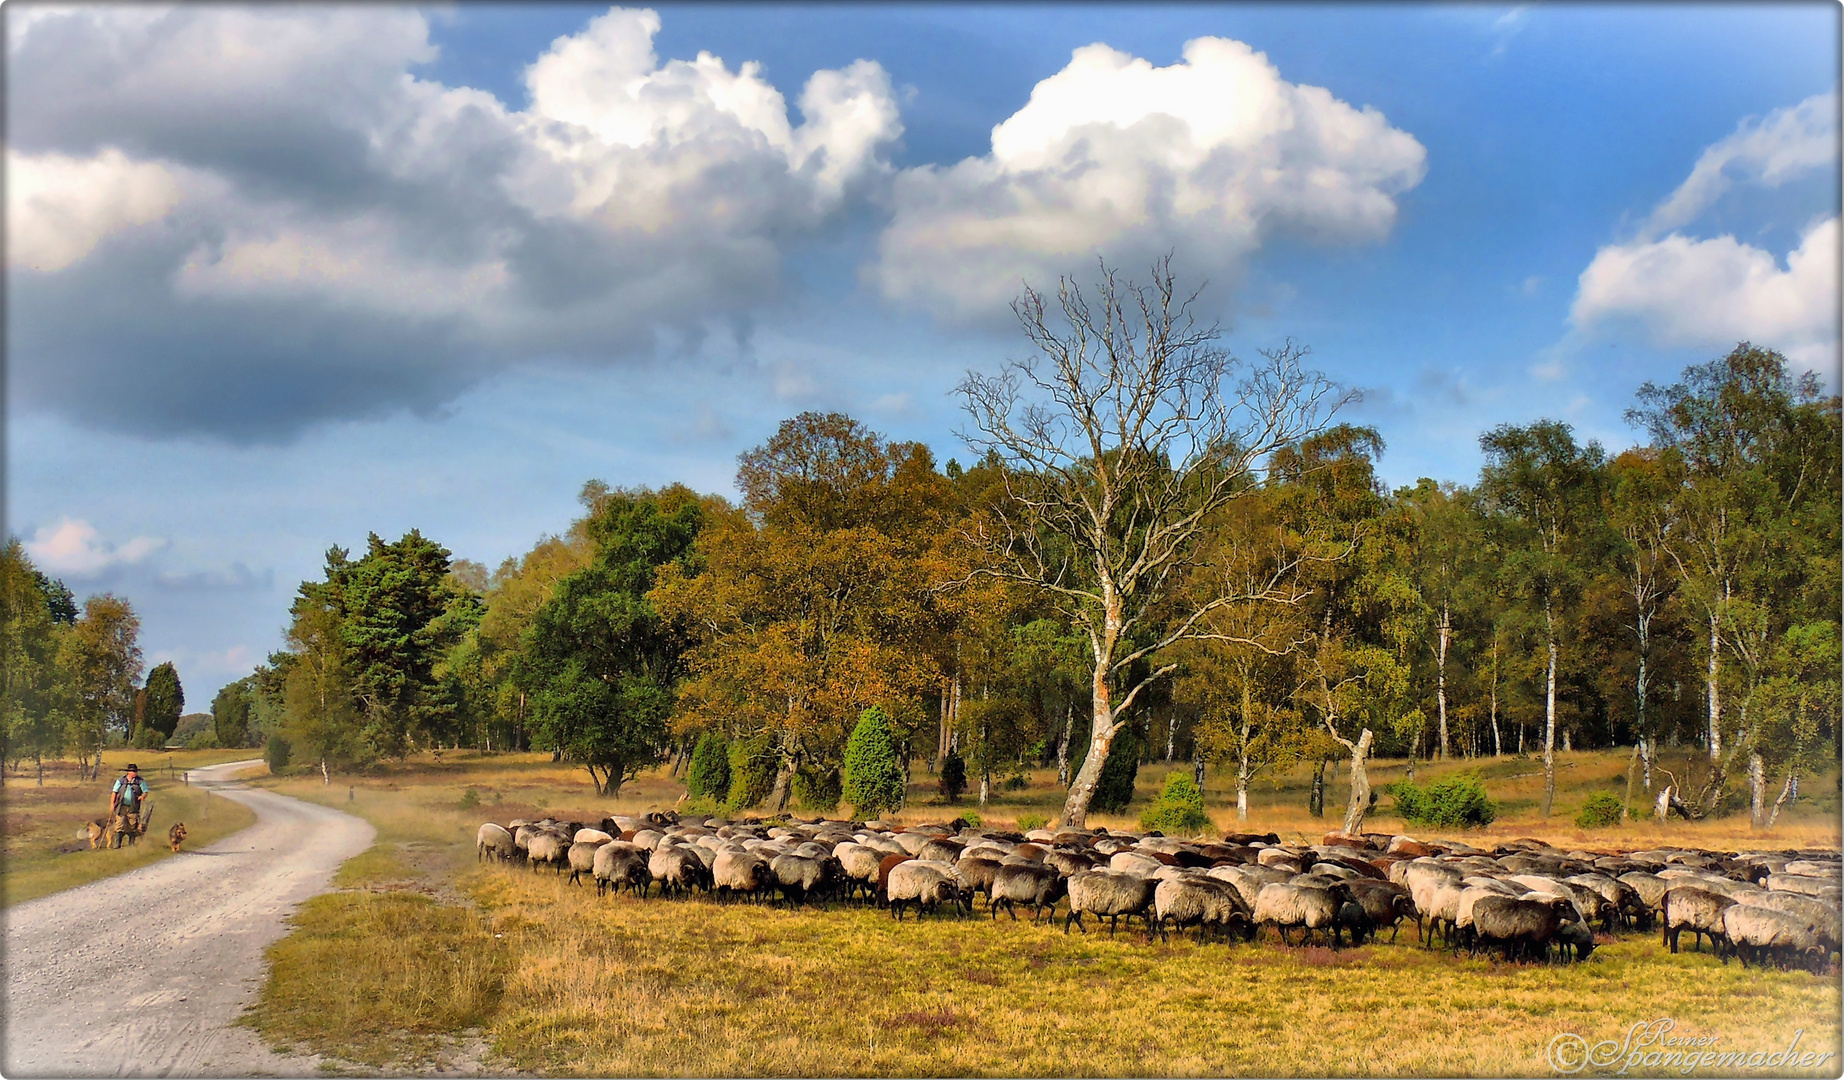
[6,6,902,440]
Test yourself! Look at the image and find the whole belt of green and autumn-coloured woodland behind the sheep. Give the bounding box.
[0,275,1840,831]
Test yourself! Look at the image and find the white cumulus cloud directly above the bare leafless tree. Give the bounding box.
[869,37,1427,319]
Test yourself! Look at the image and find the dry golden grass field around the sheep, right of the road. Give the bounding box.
[251,752,1840,1076]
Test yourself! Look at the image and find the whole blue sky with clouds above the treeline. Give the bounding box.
[0,0,1840,710]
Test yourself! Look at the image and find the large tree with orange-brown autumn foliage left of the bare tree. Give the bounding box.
[649,413,950,809]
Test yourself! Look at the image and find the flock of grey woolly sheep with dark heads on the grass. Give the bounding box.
[478,815,1840,971]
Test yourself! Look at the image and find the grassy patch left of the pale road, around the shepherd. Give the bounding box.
[0,750,256,907]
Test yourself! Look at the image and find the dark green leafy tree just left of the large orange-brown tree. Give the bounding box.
[522,485,703,798]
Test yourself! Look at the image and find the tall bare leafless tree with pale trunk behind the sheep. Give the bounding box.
[961,258,1350,828]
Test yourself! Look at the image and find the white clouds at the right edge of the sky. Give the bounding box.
[1569,92,1838,364]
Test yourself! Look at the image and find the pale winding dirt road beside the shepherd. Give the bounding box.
[0,761,376,1076]
